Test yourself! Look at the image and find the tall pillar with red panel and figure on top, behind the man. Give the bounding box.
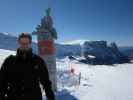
[32,8,57,91]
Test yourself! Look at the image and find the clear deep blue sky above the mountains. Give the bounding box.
[0,0,133,46]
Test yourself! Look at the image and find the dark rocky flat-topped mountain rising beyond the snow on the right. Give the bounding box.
[82,41,129,64]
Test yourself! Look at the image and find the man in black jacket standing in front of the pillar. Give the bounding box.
[0,33,55,100]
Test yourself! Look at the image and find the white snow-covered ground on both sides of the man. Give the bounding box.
[0,49,133,100]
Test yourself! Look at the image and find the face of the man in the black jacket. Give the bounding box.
[19,37,31,49]
